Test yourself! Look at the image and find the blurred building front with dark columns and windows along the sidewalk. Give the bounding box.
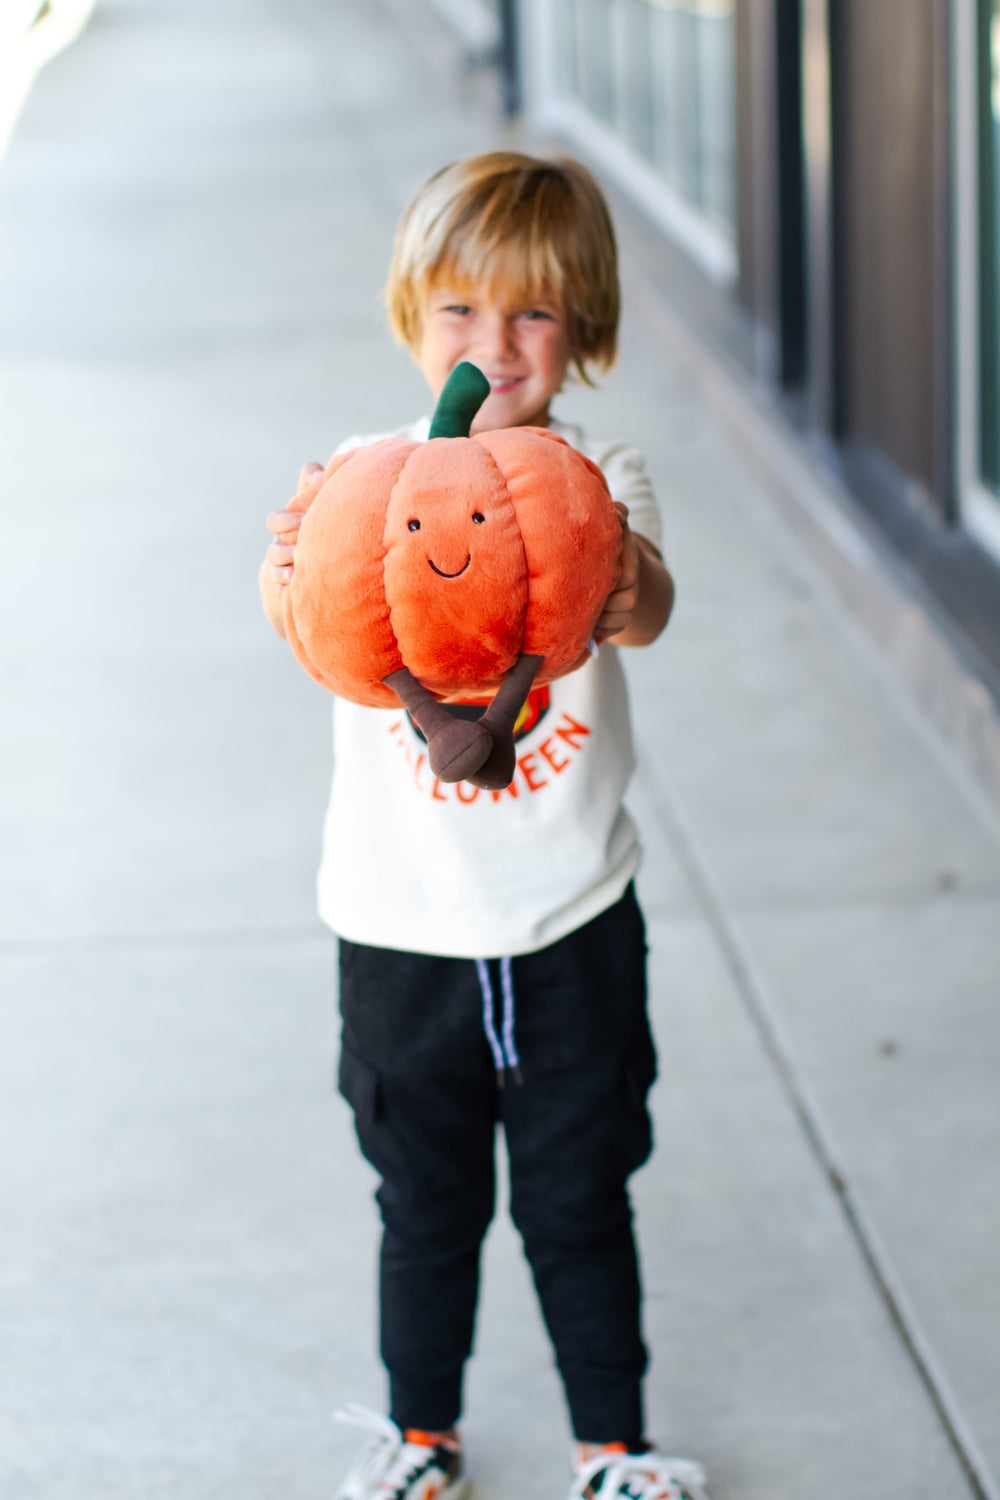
[515,0,1000,693]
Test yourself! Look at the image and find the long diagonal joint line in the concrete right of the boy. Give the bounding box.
[640,771,1000,1500]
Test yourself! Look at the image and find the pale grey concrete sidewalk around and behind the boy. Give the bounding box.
[0,0,1000,1500]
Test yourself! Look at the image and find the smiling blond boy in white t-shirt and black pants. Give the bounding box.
[261,152,702,1500]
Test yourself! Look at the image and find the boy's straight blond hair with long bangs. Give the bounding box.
[385,152,619,386]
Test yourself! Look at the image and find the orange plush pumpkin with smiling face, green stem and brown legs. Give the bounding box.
[283,363,622,789]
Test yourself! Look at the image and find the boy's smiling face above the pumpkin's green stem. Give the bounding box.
[417,284,570,432]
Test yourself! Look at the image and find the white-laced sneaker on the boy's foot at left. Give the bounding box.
[329,1406,468,1500]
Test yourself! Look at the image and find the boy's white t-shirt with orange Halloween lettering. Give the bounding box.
[318,417,660,959]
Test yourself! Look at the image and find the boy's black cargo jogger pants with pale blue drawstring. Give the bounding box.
[340,887,655,1445]
